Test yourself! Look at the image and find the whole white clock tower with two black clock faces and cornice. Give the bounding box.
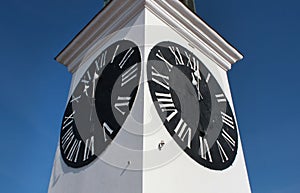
[48,0,251,193]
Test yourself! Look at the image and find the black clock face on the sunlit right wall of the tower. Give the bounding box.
[147,42,238,170]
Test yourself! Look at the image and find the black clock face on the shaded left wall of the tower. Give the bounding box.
[60,40,141,168]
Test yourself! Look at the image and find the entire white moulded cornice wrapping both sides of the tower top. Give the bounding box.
[56,0,243,72]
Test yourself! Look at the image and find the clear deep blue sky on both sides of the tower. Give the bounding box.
[0,0,300,193]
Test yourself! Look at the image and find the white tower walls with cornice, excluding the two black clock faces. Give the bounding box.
[48,0,251,193]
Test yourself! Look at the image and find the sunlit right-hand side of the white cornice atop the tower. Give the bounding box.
[146,0,243,70]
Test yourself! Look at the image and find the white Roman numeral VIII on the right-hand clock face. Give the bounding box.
[155,92,178,122]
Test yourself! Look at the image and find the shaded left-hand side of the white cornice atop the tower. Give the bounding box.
[55,0,145,72]
